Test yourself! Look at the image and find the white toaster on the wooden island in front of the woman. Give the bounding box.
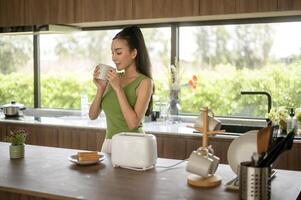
[111,132,157,170]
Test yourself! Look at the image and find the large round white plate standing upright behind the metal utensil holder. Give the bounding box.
[227,130,258,175]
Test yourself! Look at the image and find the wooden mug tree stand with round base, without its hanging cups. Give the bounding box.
[187,107,224,188]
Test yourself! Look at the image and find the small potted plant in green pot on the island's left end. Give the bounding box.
[5,129,28,158]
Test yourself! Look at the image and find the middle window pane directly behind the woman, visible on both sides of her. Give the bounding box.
[40,28,170,109]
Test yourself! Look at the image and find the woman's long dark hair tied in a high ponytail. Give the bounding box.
[113,26,154,116]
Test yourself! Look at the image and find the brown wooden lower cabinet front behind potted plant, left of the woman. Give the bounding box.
[0,123,105,151]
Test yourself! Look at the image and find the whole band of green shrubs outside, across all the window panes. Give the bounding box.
[0,59,301,117]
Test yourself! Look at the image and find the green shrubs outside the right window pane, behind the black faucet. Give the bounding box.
[180,59,301,117]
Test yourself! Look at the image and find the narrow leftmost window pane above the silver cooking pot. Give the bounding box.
[0,35,33,107]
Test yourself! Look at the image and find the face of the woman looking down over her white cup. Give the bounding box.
[111,39,137,70]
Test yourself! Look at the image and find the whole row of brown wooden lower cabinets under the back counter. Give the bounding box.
[0,122,301,171]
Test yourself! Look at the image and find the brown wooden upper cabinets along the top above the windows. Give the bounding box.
[0,0,301,27]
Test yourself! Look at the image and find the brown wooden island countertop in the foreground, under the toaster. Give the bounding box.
[0,142,301,200]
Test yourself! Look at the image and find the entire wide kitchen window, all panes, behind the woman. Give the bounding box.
[0,22,301,118]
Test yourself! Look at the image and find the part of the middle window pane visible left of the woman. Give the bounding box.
[40,30,116,109]
